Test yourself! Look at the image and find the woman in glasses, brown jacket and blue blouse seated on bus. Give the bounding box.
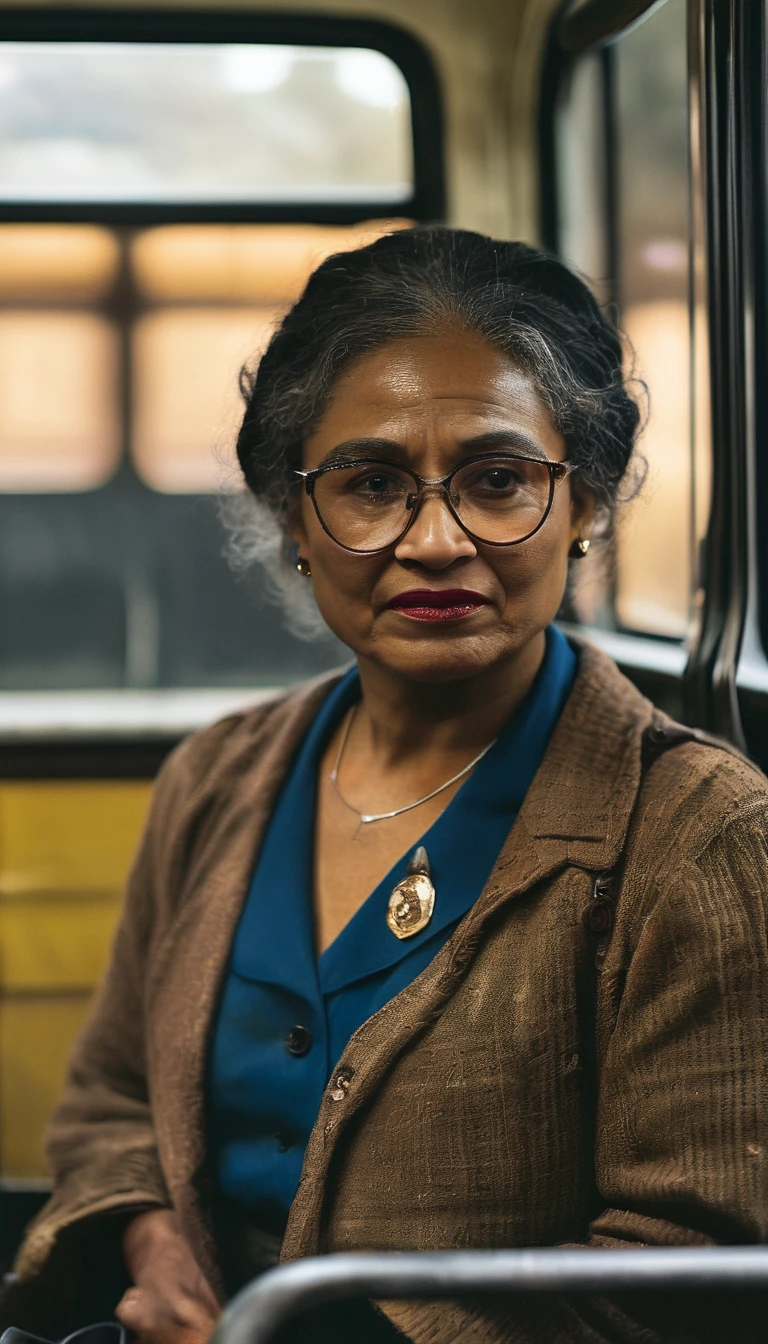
[5,228,768,1344]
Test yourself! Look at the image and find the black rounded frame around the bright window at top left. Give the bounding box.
[0,8,445,226]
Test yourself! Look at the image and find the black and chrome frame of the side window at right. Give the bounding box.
[539,0,768,765]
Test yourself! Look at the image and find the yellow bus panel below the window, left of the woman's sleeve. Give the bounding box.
[0,780,151,1177]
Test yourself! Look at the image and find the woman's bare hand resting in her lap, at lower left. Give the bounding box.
[114,1208,219,1344]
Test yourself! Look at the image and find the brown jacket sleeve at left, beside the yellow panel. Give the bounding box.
[0,745,193,1337]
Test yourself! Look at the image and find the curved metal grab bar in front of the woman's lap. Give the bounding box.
[210,1246,768,1344]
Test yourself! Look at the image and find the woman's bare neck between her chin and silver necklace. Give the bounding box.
[355,630,546,767]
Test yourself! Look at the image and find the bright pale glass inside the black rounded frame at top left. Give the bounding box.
[0,42,413,203]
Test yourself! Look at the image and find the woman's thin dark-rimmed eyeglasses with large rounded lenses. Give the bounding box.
[295,453,576,555]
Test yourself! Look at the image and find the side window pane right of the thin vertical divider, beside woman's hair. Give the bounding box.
[613,0,693,637]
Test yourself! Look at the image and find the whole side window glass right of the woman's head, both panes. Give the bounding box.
[555,0,707,640]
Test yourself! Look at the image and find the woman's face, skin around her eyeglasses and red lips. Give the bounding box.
[293,331,593,681]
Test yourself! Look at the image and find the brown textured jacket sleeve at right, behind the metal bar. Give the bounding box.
[386,796,768,1344]
